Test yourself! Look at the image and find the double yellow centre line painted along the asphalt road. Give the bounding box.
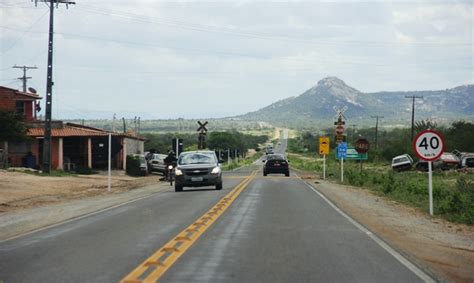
[120,171,257,283]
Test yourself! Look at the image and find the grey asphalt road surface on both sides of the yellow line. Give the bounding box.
[0,136,430,283]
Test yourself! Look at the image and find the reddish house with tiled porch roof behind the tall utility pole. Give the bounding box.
[0,87,144,170]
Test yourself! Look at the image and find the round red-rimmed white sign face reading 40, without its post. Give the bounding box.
[413,130,444,161]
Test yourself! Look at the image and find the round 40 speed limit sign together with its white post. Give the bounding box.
[413,130,445,216]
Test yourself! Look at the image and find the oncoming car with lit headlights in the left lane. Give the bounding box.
[174,151,222,192]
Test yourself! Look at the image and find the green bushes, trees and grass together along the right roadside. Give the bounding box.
[288,121,474,225]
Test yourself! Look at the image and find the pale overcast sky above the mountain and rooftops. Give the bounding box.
[0,0,474,119]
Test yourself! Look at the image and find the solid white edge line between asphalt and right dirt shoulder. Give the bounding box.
[303,181,436,282]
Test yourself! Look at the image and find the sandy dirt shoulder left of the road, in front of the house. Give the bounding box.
[0,170,171,241]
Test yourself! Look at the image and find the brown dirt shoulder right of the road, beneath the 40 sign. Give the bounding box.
[299,173,474,282]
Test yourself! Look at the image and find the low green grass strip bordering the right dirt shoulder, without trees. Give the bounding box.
[289,154,474,225]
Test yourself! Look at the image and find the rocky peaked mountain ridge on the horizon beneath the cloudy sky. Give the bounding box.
[236,77,474,126]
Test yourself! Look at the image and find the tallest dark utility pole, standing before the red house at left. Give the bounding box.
[35,0,76,174]
